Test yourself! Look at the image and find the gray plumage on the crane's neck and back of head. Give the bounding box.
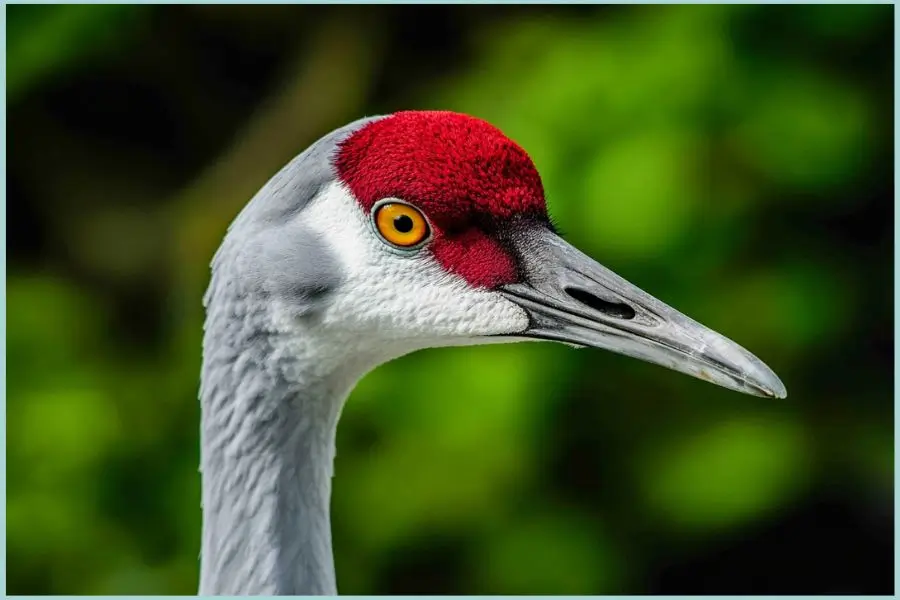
[200,117,377,595]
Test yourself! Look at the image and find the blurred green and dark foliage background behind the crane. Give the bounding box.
[7,6,894,594]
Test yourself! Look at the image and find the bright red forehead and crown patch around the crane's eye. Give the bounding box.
[335,111,547,288]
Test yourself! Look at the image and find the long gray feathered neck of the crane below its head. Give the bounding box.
[200,276,355,595]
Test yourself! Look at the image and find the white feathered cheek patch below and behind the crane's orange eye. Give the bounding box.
[300,183,528,347]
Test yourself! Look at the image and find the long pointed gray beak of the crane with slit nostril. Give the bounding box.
[499,226,787,398]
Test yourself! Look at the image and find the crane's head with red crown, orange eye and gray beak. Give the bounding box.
[227,111,786,397]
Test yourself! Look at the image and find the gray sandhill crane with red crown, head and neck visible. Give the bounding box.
[200,111,786,595]
